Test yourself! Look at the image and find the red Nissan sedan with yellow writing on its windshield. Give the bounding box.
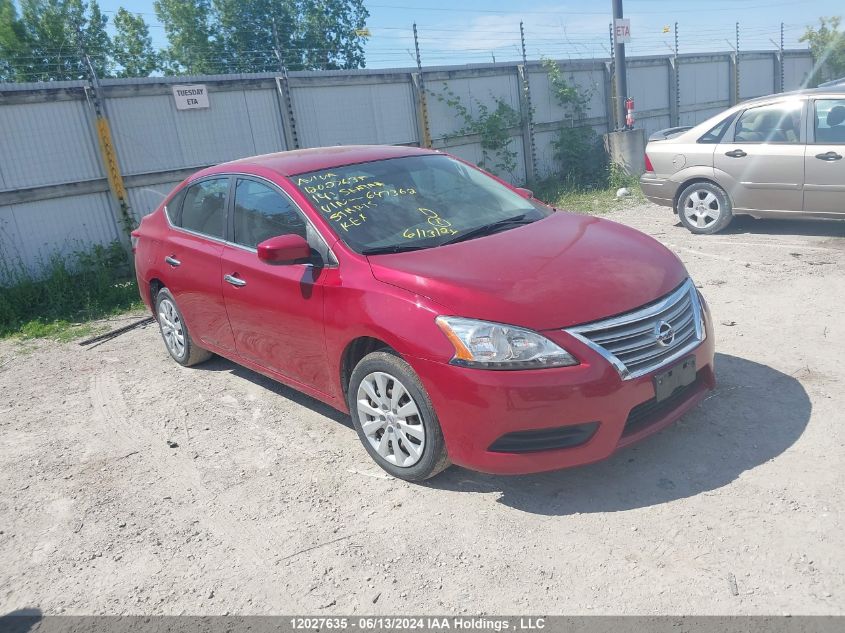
[133,146,715,480]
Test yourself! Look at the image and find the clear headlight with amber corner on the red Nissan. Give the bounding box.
[436,316,578,369]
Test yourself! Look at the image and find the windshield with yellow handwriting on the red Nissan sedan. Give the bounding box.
[291,155,552,254]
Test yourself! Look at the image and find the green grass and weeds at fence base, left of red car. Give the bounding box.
[0,243,142,341]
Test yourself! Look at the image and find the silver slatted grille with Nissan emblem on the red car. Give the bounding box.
[566,279,706,380]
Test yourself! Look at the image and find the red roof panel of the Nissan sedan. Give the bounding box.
[192,145,438,180]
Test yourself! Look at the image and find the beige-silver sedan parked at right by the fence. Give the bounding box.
[640,86,845,234]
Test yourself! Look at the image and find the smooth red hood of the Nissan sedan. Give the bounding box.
[369,212,687,330]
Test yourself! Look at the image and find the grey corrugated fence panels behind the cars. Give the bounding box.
[0,51,813,271]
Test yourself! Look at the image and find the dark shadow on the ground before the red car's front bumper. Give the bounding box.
[427,354,812,515]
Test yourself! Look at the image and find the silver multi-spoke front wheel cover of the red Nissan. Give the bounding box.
[356,371,425,468]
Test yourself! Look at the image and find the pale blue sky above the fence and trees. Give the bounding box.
[94,0,845,68]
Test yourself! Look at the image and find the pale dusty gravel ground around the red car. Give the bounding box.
[0,205,845,615]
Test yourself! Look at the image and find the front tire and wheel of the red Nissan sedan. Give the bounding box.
[347,350,450,481]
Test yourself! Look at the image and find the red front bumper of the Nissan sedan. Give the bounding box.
[408,308,716,474]
